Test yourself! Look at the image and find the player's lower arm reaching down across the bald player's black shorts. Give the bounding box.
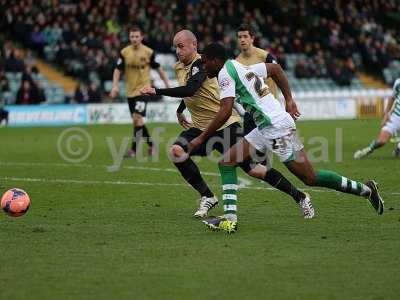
[188,97,235,153]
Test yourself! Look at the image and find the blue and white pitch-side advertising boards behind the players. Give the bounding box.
[5,89,391,127]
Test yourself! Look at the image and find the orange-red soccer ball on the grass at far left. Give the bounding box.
[1,188,31,217]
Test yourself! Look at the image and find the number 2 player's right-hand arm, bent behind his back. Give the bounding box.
[265,63,300,120]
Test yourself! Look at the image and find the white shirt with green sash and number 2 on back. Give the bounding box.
[218,60,295,129]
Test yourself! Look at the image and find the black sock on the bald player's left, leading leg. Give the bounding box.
[174,157,214,198]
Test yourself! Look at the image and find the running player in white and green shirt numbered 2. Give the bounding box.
[192,43,383,233]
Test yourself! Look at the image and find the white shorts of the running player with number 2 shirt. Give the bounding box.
[244,127,304,162]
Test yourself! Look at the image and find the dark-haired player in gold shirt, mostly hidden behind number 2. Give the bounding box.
[235,24,278,134]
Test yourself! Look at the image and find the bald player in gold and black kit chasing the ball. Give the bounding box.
[141,30,314,218]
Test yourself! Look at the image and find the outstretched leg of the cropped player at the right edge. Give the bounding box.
[354,114,400,159]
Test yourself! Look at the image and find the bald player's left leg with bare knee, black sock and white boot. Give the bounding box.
[169,128,218,218]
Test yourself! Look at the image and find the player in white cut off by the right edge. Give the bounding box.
[354,78,400,159]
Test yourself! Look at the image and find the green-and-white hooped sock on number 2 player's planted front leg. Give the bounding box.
[218,164,238,222]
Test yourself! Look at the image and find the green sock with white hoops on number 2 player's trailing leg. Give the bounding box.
[315,170,371,197]
